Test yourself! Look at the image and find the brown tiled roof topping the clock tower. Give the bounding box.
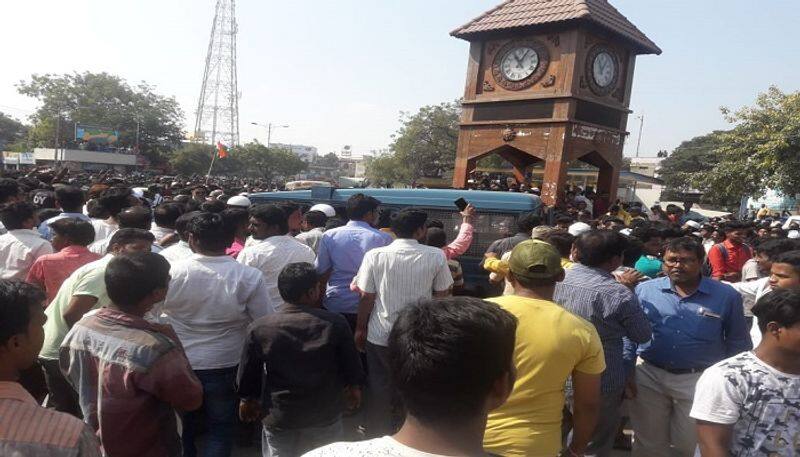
[450,0,661,54]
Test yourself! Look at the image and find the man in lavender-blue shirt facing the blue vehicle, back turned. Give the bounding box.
[316,194,392,331]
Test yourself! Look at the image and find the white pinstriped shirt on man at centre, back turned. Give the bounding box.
[353,239,453,346]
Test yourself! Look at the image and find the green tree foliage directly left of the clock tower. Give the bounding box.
[367,101,461,185]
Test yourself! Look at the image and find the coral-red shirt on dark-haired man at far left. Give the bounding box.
[25,246,101,306]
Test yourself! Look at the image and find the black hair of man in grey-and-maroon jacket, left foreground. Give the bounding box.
[105,252,170,309]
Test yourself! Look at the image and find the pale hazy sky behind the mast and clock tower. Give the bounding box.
[0,0,800,157]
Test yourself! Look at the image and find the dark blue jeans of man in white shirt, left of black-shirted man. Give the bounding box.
[182,367,238,457]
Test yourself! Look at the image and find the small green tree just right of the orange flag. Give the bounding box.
[234,141,308,182]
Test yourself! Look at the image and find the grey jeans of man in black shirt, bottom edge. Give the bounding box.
[261,419,342,457]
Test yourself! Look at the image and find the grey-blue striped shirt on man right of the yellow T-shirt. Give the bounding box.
[553,263,652,394]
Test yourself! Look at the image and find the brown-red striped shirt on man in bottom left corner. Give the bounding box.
[0,382,100,457]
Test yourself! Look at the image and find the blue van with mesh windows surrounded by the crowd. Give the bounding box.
[249,187,543,296]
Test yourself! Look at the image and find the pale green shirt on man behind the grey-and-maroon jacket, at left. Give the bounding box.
[39,255,113,360]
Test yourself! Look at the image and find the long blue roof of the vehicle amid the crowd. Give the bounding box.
[248,188,542,213]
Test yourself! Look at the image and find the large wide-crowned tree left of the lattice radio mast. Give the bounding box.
[17,72,184,163]
